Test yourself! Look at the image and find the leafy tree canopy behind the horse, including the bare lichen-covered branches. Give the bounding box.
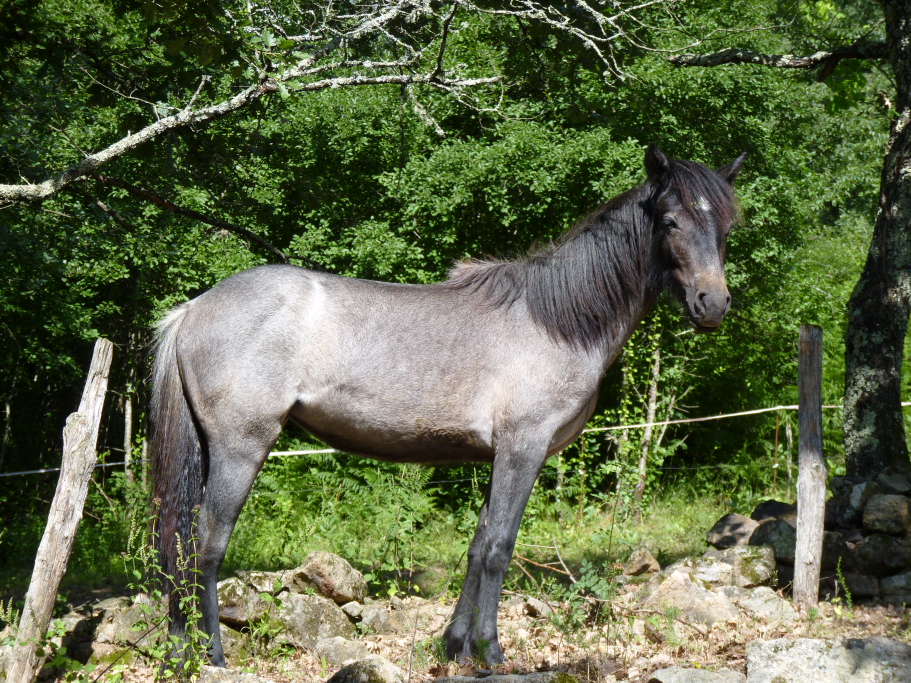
[0,0,894,536]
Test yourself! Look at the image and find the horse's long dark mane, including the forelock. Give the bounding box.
[441,159,737,349]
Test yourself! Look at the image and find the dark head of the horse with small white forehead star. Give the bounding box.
[645,145,747,332]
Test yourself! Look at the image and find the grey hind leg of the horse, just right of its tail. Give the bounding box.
[197,430,281,667]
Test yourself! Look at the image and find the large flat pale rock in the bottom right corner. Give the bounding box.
[747,637,911,683]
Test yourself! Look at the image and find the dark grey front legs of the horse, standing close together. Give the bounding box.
[444,445,547,664]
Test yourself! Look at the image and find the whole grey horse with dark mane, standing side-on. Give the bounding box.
[150,144,746,667]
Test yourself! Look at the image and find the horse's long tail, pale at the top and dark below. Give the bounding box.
[149,303,203,633]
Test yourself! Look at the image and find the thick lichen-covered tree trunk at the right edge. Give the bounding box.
[844,0,911,478]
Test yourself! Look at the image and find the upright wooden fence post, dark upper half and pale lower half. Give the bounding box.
[794,325,826,610]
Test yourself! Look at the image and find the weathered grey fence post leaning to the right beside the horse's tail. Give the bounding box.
[7,339,114,683]
